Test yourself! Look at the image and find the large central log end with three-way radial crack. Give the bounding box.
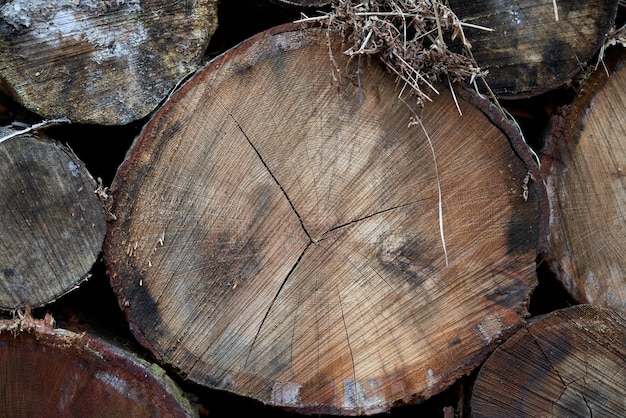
[104,25,546,415]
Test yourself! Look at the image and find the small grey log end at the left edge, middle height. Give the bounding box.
[0,129,106,310]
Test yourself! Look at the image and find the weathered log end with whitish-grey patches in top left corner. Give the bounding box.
[0,0,217,125]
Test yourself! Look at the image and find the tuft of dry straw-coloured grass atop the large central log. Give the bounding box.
[299,0,491,107]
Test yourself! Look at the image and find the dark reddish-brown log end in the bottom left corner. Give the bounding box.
[0,315,199,418]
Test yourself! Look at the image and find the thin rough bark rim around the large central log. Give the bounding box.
[105,23,548,416]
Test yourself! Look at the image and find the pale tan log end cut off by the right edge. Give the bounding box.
[542,49,626,313]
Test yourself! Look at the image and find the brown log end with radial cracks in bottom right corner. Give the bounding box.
[471,305,626,418]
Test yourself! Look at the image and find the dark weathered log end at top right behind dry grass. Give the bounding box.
[450,0,619,99]
